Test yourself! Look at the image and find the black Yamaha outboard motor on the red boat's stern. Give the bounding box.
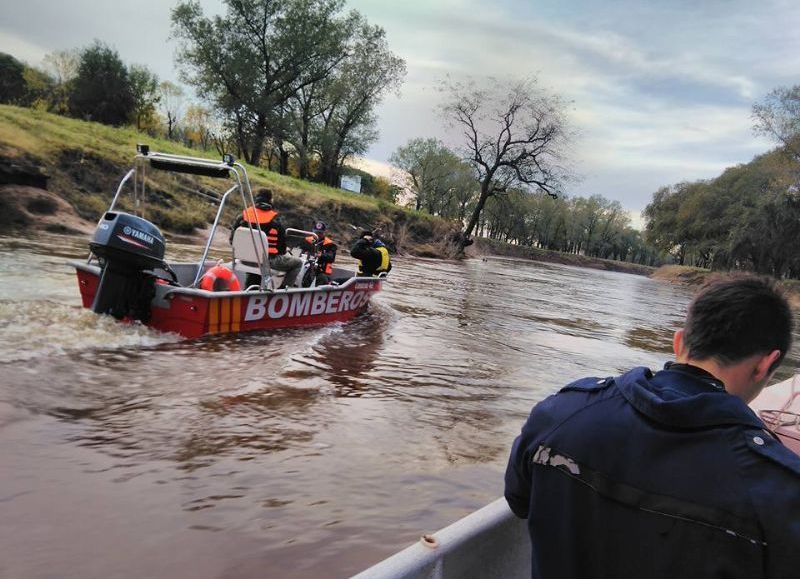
[89,211,166,322]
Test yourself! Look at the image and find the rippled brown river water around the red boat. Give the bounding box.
[0,236,798,579]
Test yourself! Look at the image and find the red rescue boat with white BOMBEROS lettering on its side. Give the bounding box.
[70,145,385,338]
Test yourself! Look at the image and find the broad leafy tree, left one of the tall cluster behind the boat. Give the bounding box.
[172,0,347,165]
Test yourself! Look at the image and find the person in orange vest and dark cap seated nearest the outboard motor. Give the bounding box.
[231,188,303,289]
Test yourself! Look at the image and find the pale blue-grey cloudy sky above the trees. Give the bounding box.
[0,0,800,218]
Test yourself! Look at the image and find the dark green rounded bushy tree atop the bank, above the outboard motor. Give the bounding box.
[69,41,135,125]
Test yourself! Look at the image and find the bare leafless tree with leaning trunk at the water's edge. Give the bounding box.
[441,79,568,249]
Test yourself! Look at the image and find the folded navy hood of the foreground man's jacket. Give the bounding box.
[615,366,764,428]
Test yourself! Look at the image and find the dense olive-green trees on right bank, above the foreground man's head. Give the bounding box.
[645,150,800,278]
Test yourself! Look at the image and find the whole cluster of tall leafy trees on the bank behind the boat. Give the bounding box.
[172,0,405,186]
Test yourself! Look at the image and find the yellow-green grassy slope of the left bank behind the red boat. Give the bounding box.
[0,105,451,253]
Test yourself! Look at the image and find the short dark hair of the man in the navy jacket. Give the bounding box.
[683,274,792,367]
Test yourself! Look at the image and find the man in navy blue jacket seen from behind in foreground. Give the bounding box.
[505,276,800,579]
